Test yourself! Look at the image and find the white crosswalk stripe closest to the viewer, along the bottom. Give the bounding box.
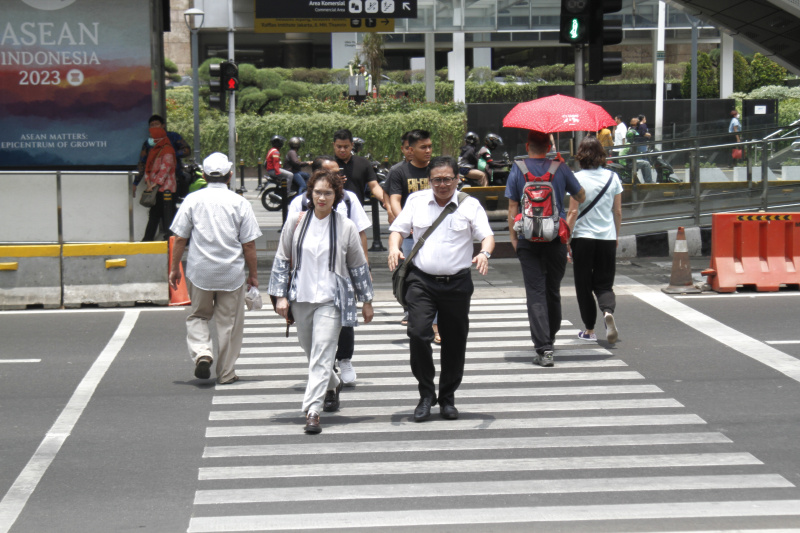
[188,500,800,533]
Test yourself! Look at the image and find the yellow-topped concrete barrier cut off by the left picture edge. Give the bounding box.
[0,244,61,310]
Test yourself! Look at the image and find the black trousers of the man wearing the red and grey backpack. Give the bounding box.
[517,239,567,354]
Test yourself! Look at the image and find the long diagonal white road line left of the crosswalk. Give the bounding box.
[0,309,140,533]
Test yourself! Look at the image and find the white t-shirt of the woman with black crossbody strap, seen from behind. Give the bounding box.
[572,167,622,241]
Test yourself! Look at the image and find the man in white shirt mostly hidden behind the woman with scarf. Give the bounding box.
[289,155,372,386]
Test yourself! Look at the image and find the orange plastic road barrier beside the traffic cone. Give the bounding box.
[703,213,800,292]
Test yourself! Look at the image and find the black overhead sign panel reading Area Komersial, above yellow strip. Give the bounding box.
[255,0,417,20]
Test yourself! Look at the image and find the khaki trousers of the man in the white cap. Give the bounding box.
[186,283,245,383]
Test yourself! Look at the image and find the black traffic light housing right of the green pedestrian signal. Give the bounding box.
[588,0,622,83]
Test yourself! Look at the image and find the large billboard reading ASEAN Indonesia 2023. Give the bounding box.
[0,0,152,170]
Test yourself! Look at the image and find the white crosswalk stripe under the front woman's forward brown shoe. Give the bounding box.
[206,412,706,438]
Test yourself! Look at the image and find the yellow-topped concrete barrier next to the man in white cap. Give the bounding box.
[62,241,169,307]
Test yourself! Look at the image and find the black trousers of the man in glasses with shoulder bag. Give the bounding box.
[406,267,474,405]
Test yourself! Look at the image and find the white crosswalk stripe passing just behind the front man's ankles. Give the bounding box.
[211,385,664,405]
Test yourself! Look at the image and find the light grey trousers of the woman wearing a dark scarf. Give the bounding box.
[291,302,342,413]
